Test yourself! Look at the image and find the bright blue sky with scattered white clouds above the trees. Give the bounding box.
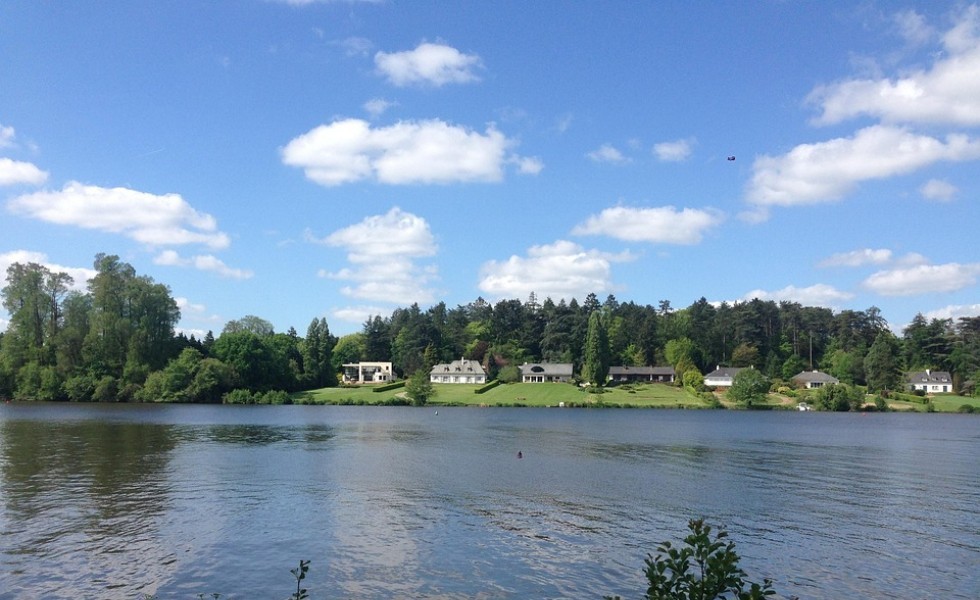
[0,0,980,335]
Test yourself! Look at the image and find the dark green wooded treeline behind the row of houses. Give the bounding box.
[350,294,980,390]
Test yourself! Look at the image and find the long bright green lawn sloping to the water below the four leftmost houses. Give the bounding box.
[293,383,707,408]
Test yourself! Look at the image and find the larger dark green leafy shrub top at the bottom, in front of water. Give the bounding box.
[604,519,776,600]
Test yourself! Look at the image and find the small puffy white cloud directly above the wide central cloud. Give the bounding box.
[374,42,482,87]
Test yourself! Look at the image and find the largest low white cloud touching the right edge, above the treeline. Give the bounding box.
[862,263,980,296]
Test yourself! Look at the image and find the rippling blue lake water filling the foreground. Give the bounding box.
[0,404,980,600]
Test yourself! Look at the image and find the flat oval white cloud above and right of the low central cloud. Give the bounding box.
[572,206,723,245]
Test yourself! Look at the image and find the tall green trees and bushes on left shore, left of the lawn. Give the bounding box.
[0,254,336,402]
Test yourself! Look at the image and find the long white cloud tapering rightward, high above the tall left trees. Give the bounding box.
[7,181,230,248]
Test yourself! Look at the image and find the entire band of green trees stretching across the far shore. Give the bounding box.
[0,254,980,402]
